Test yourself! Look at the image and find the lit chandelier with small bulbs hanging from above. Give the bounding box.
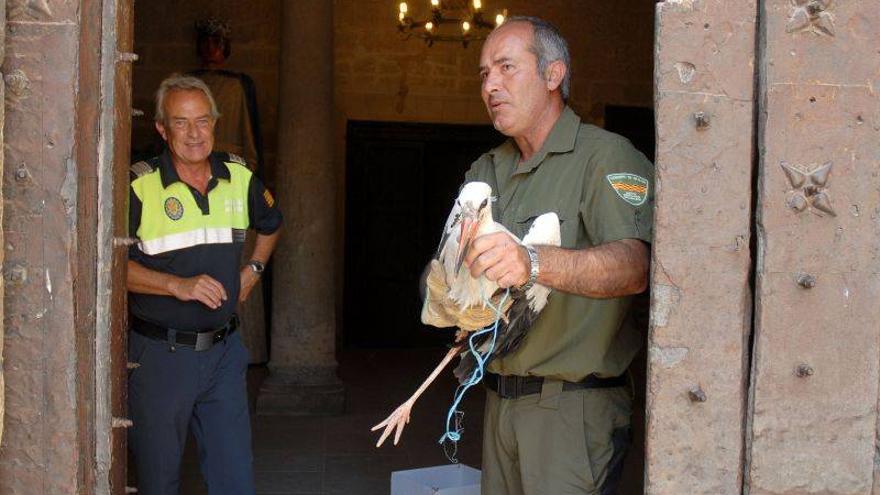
[397,0,507,48]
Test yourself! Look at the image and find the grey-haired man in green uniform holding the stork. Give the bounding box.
[465,17,654,495]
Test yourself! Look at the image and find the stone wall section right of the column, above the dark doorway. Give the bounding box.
[335,0,654,128]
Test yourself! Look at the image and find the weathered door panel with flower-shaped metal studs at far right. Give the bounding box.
[748,0,880,495]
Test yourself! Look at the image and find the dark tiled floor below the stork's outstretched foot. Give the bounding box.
[181,349,485,495]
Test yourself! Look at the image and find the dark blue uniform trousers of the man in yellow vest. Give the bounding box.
[128,332,255,495]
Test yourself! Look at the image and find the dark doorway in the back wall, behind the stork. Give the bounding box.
[342,121,504,348]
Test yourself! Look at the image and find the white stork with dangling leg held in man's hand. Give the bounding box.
[371,182,561,447]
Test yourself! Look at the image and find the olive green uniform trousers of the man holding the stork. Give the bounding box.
[482,380,632,495]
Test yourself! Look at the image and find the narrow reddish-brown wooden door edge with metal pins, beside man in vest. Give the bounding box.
[96,0,137,495]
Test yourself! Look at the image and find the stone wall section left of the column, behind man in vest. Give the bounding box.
[132,0,282,183]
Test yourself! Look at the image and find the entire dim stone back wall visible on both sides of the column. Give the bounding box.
[132,0,653,185]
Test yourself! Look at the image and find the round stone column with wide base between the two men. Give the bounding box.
[257,0,344,414]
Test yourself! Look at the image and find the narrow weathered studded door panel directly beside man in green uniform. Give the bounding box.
[645,0,757,495]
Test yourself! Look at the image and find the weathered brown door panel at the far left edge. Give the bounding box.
[0,0,79,494]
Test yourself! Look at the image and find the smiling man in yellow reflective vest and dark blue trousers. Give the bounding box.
[128,75,281,495]
